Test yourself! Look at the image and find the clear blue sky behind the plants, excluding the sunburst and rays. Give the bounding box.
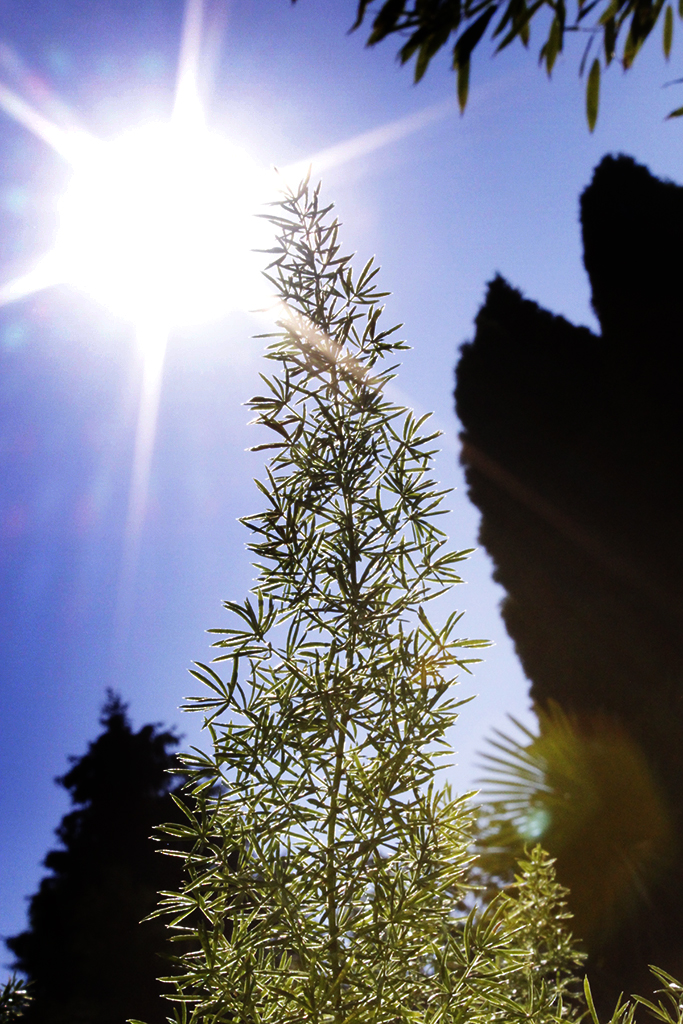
[0,0,683,959]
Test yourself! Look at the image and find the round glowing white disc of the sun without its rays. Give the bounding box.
[51,119,267,330]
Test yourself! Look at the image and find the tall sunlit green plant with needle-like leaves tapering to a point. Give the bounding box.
[157,182,577,1024]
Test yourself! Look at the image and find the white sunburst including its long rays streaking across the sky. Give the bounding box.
[0,0,455,640]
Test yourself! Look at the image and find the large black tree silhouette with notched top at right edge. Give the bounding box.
[456,156,683,998]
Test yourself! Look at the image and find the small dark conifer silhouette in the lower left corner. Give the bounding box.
[7,691,187,1024]
